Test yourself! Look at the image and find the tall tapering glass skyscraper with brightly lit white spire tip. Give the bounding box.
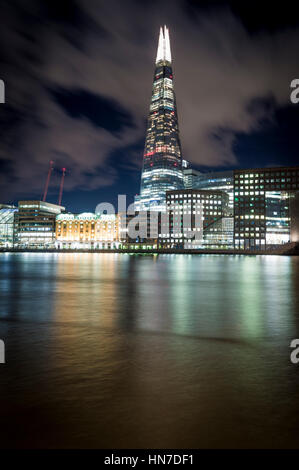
[135,26,184,210]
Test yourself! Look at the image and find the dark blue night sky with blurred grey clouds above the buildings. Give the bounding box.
[0,0,299,212]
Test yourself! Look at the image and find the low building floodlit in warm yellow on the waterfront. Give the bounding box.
[56,212,119,249]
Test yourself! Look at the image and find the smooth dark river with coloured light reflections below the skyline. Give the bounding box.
[0,254,299,448]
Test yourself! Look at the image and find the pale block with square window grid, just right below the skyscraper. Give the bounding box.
[160,189,233,249]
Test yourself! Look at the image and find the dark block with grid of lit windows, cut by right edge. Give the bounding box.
[234,167,299,250]
